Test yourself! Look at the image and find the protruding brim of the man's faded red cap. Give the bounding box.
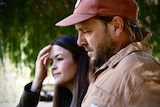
[55,13,95,26]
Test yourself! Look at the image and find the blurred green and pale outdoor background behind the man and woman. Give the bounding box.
[0,0,160,103]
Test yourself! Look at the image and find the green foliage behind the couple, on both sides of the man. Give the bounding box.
[0,0,160,74]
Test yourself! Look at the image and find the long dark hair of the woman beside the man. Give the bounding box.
[51,35,89,107]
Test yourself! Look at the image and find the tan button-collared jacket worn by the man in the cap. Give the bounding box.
[82,42,160,107]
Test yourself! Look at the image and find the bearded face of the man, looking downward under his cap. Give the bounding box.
[75,18,117,67]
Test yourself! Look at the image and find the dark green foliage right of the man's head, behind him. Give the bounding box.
[136,0,160,61]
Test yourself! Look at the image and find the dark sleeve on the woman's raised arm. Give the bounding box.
[17,82,41,107]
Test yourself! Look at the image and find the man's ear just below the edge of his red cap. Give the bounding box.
[112,16,124,36]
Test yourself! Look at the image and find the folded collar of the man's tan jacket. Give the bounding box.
[93,42,152,79]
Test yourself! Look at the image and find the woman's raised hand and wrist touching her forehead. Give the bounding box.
[31,45,51,92]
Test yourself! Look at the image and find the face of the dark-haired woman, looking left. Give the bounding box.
[49,45,77,88]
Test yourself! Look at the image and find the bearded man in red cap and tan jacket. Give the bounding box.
[56,0,160,107]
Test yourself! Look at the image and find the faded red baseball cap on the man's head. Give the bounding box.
[56,0,138,26]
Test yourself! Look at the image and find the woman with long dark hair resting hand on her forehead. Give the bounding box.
[17,35,89,107]
